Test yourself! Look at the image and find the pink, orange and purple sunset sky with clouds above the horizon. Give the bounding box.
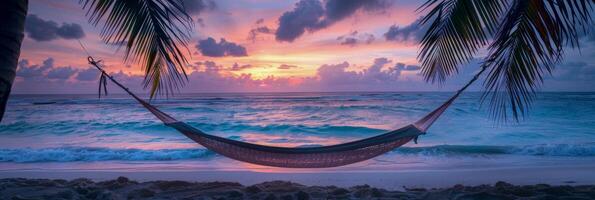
[13,0,595,94]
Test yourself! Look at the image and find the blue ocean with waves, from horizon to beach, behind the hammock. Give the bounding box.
[0,92,595,171]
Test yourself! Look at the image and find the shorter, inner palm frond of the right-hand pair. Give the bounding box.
[418,0,506,82]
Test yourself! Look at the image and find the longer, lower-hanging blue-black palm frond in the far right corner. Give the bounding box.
[482,0,592,121]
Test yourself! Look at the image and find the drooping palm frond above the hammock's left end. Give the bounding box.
[79,0,192,98]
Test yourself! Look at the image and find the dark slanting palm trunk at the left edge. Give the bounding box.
[0,0,29,122]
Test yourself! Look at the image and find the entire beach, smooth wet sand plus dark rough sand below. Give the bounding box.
[0,165,595,199]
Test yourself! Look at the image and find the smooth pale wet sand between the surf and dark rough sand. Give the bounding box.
[0,164,595,190]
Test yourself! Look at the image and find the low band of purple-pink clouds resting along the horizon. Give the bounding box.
[15,58,494,93]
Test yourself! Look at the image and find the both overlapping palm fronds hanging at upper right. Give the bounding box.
[418,0,595,121]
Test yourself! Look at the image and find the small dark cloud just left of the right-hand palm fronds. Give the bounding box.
[384,18,427,43]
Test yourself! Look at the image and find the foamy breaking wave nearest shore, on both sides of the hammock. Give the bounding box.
[0,144,595,163]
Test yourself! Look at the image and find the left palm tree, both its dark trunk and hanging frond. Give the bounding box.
[0,0,193,121]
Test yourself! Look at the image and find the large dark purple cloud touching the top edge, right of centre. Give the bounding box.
[275,0,390,42]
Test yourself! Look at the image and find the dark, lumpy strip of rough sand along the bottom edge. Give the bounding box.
[0,177,595,200]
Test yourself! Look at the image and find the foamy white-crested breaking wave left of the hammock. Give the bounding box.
[0,147,215,163]
